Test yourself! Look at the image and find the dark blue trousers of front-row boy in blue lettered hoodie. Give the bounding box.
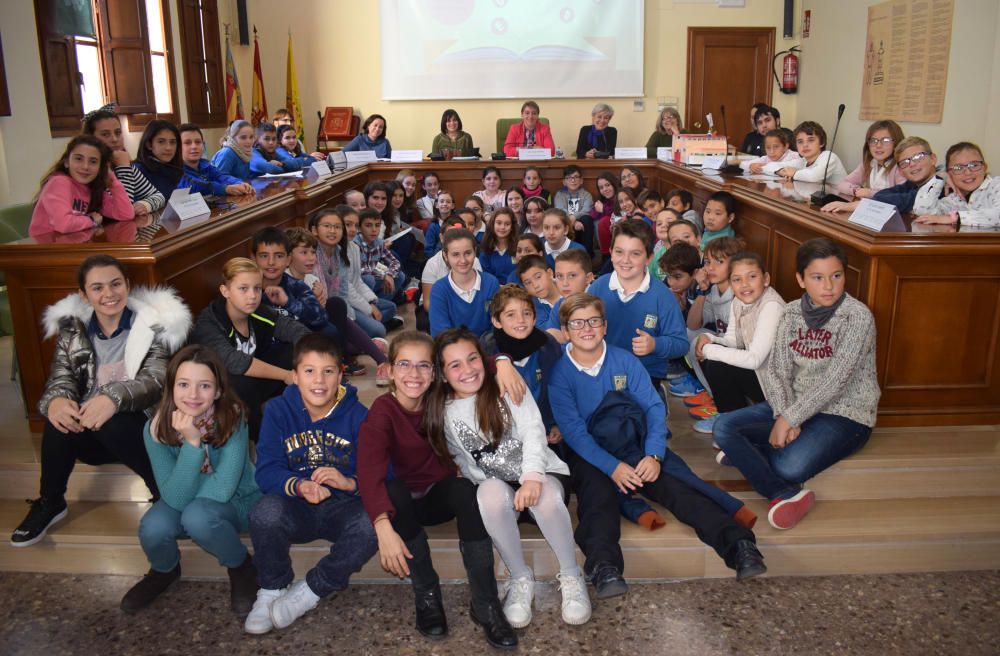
[250,493,378,597]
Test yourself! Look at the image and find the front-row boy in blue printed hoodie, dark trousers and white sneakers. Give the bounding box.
[244,333,378,634]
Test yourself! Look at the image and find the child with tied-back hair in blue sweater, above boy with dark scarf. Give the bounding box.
[428,228,500,336]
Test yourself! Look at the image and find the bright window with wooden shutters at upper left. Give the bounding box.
[35,0,178,136]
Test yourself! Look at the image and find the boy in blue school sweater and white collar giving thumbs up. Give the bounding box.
[588,219,689,390]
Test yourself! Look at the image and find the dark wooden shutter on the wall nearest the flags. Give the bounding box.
[179,0,226,127]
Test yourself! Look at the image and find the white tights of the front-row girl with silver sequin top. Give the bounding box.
[476,474,580,578]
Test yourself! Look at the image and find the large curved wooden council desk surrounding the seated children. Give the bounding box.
[0,160,1000,430]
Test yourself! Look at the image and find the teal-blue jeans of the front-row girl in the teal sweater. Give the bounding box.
[139,497,247,572]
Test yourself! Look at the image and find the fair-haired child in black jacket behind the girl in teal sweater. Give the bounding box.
[191,257,309,443]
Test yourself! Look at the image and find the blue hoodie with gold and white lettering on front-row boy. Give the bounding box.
[257,385,368,497]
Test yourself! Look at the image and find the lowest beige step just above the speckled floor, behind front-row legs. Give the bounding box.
[0,497,1000,582]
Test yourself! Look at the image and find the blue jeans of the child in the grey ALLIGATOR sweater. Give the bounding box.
[713,401,872,499]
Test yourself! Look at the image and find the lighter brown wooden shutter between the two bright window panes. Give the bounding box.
[97,0,156,114]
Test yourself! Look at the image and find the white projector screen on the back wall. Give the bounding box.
[381,0,643,100]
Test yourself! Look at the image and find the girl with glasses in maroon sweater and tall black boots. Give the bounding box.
[357,330,525,647]
